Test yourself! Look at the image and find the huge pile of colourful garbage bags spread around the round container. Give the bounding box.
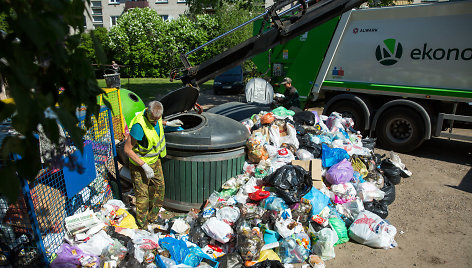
[51,107,411,268]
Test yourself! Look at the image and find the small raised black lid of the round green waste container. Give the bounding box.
[160,86,200,117]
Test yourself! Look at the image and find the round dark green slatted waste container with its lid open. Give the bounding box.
[161,87,249,211]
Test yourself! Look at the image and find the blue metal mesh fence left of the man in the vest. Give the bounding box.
[0,105,121,267]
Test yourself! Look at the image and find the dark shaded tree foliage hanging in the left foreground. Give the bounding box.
[0,0,104,200]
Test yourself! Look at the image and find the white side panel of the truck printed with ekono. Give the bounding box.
[313,1,472,90]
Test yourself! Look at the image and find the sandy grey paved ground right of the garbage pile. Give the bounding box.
[198,91,472,268]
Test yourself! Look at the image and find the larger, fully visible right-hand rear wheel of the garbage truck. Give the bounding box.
[376,107,425,152]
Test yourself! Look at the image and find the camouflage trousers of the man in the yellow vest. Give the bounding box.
[130,160,165,228]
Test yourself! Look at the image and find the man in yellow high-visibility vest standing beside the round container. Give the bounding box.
[124,101,183,228]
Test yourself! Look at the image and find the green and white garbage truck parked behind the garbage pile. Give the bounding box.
[253,1,472,152]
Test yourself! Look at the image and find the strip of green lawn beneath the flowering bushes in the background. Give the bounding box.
[97,78,213,103]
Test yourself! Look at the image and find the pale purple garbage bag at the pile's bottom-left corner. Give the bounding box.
[51,243,100,268]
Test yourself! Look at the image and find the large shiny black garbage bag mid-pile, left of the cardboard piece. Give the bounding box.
[264,165,312,204]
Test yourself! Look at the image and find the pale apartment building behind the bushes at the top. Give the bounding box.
[84,0,188,30]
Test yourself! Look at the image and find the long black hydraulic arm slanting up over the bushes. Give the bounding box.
[177,0,365,86]
